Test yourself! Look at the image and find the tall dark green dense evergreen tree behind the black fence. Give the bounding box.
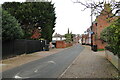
[2,2,56,41]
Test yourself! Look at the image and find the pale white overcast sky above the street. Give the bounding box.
[0,0,119,34]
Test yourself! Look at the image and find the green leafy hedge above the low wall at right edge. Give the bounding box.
[101,18,120,57]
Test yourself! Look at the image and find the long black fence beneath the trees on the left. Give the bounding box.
[2,40,45,59]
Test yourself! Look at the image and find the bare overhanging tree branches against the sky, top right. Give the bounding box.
[74,0,120,17]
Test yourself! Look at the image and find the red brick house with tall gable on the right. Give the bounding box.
[91,4,116,49]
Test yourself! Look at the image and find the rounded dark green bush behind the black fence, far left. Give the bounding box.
[0,9,23,41]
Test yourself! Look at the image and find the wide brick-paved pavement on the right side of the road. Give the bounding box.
[60,46,120,80]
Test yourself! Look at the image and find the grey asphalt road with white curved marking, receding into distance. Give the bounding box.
[2,44,84,79]
